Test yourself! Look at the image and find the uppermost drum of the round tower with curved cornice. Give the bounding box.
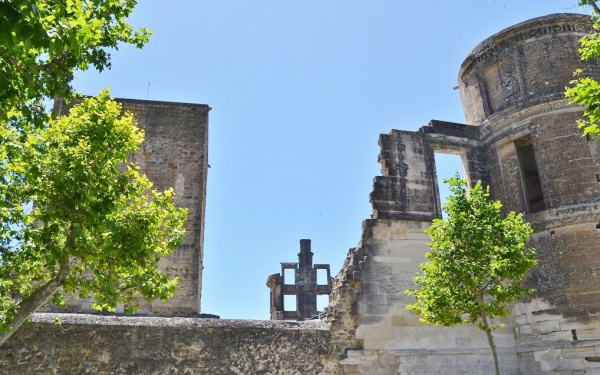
[458,13,599,125]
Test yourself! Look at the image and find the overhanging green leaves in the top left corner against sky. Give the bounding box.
[0,0,151,126]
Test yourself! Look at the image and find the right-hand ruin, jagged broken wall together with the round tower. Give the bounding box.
[329,14,600,375]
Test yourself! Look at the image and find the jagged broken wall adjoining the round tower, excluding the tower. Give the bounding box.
[329,136,519,375]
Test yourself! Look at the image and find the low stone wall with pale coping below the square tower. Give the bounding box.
[0,314,330,375]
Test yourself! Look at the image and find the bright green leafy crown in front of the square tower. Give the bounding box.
[0,90,187,329]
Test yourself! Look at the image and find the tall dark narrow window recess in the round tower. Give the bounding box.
[515,135,546,214]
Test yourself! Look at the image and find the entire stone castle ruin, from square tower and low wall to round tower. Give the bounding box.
[0,14,600,375]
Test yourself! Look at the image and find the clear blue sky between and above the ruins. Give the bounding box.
[75,0,588,319]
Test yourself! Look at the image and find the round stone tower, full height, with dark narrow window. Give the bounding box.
[459,14,600,373]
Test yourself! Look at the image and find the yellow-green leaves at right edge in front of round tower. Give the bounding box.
[566,0,600,138]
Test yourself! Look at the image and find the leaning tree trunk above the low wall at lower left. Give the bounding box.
[0,262,71,346]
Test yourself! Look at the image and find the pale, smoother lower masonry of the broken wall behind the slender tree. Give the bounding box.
[332,220,520,375]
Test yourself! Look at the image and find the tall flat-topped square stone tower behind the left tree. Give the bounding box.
[49,99,210,316]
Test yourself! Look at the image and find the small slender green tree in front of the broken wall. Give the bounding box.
[406,175,537,374]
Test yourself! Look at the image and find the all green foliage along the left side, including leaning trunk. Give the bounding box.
[0,0,187,345]
